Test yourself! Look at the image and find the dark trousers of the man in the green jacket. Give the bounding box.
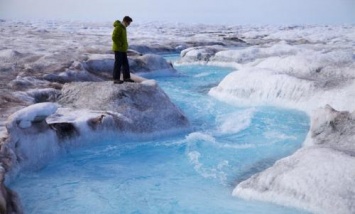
[113,51,131,80]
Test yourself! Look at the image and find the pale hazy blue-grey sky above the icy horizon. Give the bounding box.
[0,0,355,25]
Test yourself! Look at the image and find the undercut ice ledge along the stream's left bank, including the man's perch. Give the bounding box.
[0,80,189,213]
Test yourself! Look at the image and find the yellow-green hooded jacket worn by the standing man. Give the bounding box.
[112,20,128,52]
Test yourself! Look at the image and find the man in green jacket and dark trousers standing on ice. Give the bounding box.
[112,16,134,84]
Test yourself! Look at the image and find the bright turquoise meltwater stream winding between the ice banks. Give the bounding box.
[10,57,309,214]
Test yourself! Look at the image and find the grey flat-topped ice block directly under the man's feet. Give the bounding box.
[58,81,189,133]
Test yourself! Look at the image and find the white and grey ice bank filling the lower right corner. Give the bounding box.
[233,106,355,214]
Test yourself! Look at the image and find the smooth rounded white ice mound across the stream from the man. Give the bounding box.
[209,68,317,107]
